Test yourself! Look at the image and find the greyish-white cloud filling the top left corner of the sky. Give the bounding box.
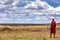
[0,0,19,9]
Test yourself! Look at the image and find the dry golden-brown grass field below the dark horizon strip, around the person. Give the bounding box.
[0,24,60,40]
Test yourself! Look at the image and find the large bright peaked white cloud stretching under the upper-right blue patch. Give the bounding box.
[24,0,60,14]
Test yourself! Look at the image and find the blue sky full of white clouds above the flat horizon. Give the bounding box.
[0,0,60,24]
